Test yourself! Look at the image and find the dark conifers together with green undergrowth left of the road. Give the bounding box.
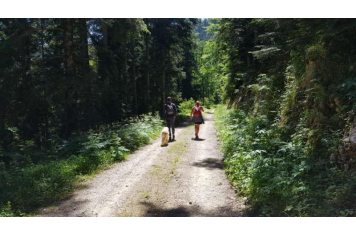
[0,18,197,214]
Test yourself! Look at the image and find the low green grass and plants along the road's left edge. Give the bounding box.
[0,115,163,216]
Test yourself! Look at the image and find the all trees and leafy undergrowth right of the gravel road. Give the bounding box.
[209,19,356,216]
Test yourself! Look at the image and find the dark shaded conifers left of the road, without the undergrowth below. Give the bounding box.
[0,18,197,147]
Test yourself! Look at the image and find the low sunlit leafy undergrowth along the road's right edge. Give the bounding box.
[214,106,356,216]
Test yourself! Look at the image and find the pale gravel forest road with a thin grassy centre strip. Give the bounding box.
[38,114,244,216]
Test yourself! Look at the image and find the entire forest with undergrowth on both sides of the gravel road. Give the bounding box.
[0,18,356,216]
